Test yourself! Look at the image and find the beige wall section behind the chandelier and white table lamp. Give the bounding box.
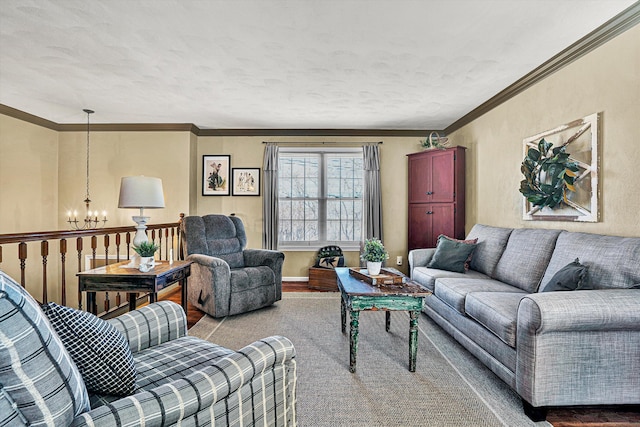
[58,132,192,229]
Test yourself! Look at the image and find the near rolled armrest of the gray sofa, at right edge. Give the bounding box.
[516,289,640,407]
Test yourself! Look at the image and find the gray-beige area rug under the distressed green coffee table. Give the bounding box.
[189,293,550,426]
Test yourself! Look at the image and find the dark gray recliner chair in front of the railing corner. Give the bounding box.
[182,215,284,317]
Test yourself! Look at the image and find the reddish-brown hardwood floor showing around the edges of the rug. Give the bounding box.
[162,282,640,427]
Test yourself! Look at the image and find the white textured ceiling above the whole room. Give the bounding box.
[0,0,634,129]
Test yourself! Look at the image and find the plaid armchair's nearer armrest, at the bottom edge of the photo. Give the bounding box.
[72,336,296,427]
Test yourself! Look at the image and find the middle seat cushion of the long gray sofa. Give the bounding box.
[434,278,526,314]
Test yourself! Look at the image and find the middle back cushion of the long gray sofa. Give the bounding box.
[492,228,561,292]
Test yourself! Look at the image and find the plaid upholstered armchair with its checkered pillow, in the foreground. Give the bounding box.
[0,271,296,427]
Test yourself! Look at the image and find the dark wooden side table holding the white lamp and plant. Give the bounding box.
[76,261,191,314]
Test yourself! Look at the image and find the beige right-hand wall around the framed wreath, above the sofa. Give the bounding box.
[450,26,640,236]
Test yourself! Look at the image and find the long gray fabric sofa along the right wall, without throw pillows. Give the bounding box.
[409,224,640,421]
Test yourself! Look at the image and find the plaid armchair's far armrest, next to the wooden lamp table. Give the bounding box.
[107,301,187,353]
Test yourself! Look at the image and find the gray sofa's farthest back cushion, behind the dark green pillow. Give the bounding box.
[467,224,513,276]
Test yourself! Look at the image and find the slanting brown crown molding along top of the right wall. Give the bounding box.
[444,2,640,135]
